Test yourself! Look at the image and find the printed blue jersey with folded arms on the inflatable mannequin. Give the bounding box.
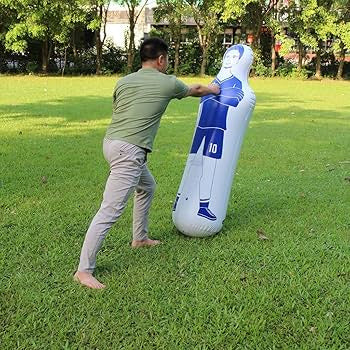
[198,76,244,130]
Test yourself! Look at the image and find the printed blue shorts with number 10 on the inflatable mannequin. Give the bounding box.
[190,127,224,159]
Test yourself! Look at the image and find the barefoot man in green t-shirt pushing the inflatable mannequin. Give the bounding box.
[74,38,220,289]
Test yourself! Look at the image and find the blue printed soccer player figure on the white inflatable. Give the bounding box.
[173,45,244,221]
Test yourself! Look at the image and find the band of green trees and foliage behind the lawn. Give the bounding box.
[0,0,350,77]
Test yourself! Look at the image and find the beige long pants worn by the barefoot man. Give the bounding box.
[78,139,156,273]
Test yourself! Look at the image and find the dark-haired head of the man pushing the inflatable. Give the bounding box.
[140,38,168,73]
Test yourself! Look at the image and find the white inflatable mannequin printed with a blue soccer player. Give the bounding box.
[173,45,255,237]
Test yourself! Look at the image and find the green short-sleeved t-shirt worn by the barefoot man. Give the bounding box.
[106,68,189,151]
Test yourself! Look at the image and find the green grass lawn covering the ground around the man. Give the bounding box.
[0,77,350,350]
